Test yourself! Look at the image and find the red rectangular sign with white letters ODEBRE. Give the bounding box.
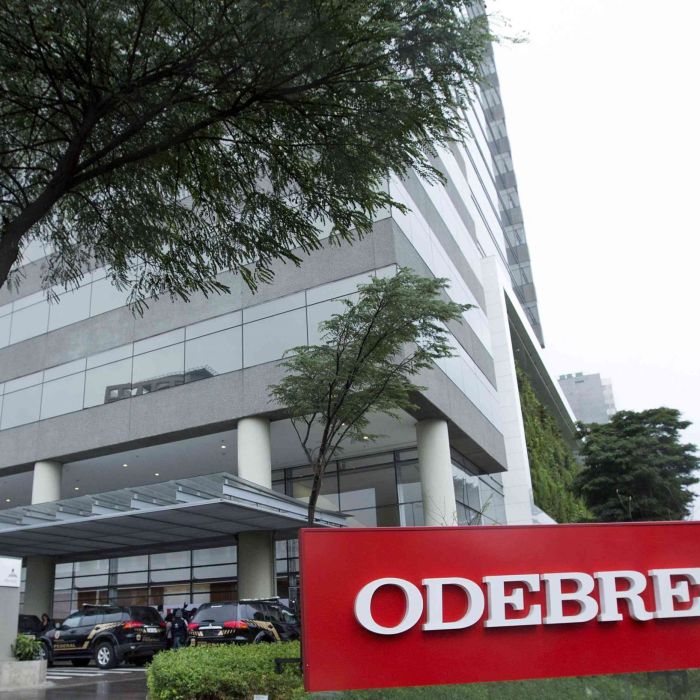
[301,522,700,691]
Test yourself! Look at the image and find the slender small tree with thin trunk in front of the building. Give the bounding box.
[270,269,471,525]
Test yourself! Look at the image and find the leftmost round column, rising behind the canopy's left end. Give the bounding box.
[22,461,62,616]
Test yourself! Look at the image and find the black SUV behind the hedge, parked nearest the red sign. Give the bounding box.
[187,598,299,646]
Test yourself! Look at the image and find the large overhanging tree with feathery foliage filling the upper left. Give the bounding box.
[0,0,490,308]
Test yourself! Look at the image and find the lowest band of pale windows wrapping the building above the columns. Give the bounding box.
[0,266,498,430]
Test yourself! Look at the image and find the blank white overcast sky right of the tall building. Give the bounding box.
[488,0,700,519]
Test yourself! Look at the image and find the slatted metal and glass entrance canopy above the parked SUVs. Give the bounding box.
[0,473,346,560]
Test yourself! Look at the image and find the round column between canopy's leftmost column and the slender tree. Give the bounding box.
[237,416,277,599]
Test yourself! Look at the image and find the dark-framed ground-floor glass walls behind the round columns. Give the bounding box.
[41,449,505,619]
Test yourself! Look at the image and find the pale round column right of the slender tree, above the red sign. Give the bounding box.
[416,420,457,526]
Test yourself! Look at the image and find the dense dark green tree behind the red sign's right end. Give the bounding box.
[578,407,700,522]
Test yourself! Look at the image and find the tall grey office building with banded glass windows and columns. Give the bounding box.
[0,15,573,618]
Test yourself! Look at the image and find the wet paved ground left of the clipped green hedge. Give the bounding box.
[0,664,146,700]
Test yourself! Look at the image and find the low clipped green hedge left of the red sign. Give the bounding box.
[148,642,304,700]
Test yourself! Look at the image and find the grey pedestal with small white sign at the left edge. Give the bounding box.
[0,558,46,691]
